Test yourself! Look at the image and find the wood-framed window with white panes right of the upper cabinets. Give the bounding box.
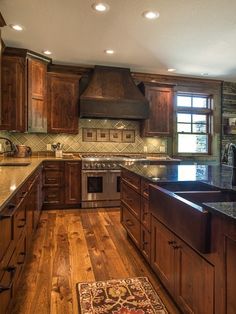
[177,94,212,154]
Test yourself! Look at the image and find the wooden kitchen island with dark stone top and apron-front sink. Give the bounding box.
[121,164,236,314]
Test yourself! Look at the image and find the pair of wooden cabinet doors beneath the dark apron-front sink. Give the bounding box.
[151,217,215,314]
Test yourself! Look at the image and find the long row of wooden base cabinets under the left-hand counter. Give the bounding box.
[0,169,40,313]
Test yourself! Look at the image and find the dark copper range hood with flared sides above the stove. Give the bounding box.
[80,66,149,120]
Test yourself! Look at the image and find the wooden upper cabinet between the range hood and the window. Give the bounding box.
[139,83,173,137]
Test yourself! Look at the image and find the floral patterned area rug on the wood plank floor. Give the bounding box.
[77,277,168,314]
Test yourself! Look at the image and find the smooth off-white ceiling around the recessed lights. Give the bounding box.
[0,0,236,81]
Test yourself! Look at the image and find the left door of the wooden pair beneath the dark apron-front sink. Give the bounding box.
[151,217,175,293]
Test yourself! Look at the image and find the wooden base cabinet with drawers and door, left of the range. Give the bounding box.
[43,160,81,209]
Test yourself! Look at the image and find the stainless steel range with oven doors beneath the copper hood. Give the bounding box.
[81,155,138,208]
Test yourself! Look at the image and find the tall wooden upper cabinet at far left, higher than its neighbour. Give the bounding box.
[0,48,51,133]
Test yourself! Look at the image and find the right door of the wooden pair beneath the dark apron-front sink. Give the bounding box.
[174,240,215,314]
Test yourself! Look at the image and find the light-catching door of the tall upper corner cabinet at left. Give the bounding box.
[27,58,47,133]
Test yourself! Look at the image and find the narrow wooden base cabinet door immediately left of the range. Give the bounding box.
[65,161,81,205]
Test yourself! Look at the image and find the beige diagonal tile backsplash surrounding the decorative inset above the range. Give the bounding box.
[0,119,167,154]
